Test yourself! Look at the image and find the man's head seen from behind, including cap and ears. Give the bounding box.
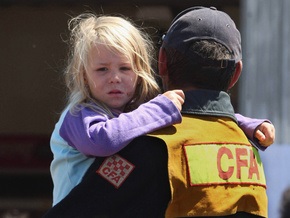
[159,7,242,91]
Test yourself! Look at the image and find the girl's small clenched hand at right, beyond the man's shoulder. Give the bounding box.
[254,122,275,147]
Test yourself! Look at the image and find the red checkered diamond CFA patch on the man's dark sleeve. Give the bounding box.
[97,154,135,188]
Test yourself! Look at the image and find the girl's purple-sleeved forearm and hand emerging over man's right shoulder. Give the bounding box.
[235,114,275,150]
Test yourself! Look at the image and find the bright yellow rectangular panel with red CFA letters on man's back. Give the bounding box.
[184,143,266,186]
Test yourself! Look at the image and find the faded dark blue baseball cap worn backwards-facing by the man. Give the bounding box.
[162,7,242,63]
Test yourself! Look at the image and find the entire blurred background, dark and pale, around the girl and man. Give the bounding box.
[0,0,290,218]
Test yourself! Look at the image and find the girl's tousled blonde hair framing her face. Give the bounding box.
[65,13,160,116]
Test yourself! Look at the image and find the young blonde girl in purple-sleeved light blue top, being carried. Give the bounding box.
[51,14,274,205]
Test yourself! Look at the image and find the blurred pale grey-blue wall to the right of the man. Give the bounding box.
[238,0,290,218]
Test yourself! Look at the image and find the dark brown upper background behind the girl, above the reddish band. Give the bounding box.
[0,0,239,134]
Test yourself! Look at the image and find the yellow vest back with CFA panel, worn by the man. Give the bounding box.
[150,115,267,217]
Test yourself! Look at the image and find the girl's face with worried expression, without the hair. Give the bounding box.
[85,45,137,111]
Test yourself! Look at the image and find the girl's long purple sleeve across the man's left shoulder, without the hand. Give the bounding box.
[60,95,181,156]
